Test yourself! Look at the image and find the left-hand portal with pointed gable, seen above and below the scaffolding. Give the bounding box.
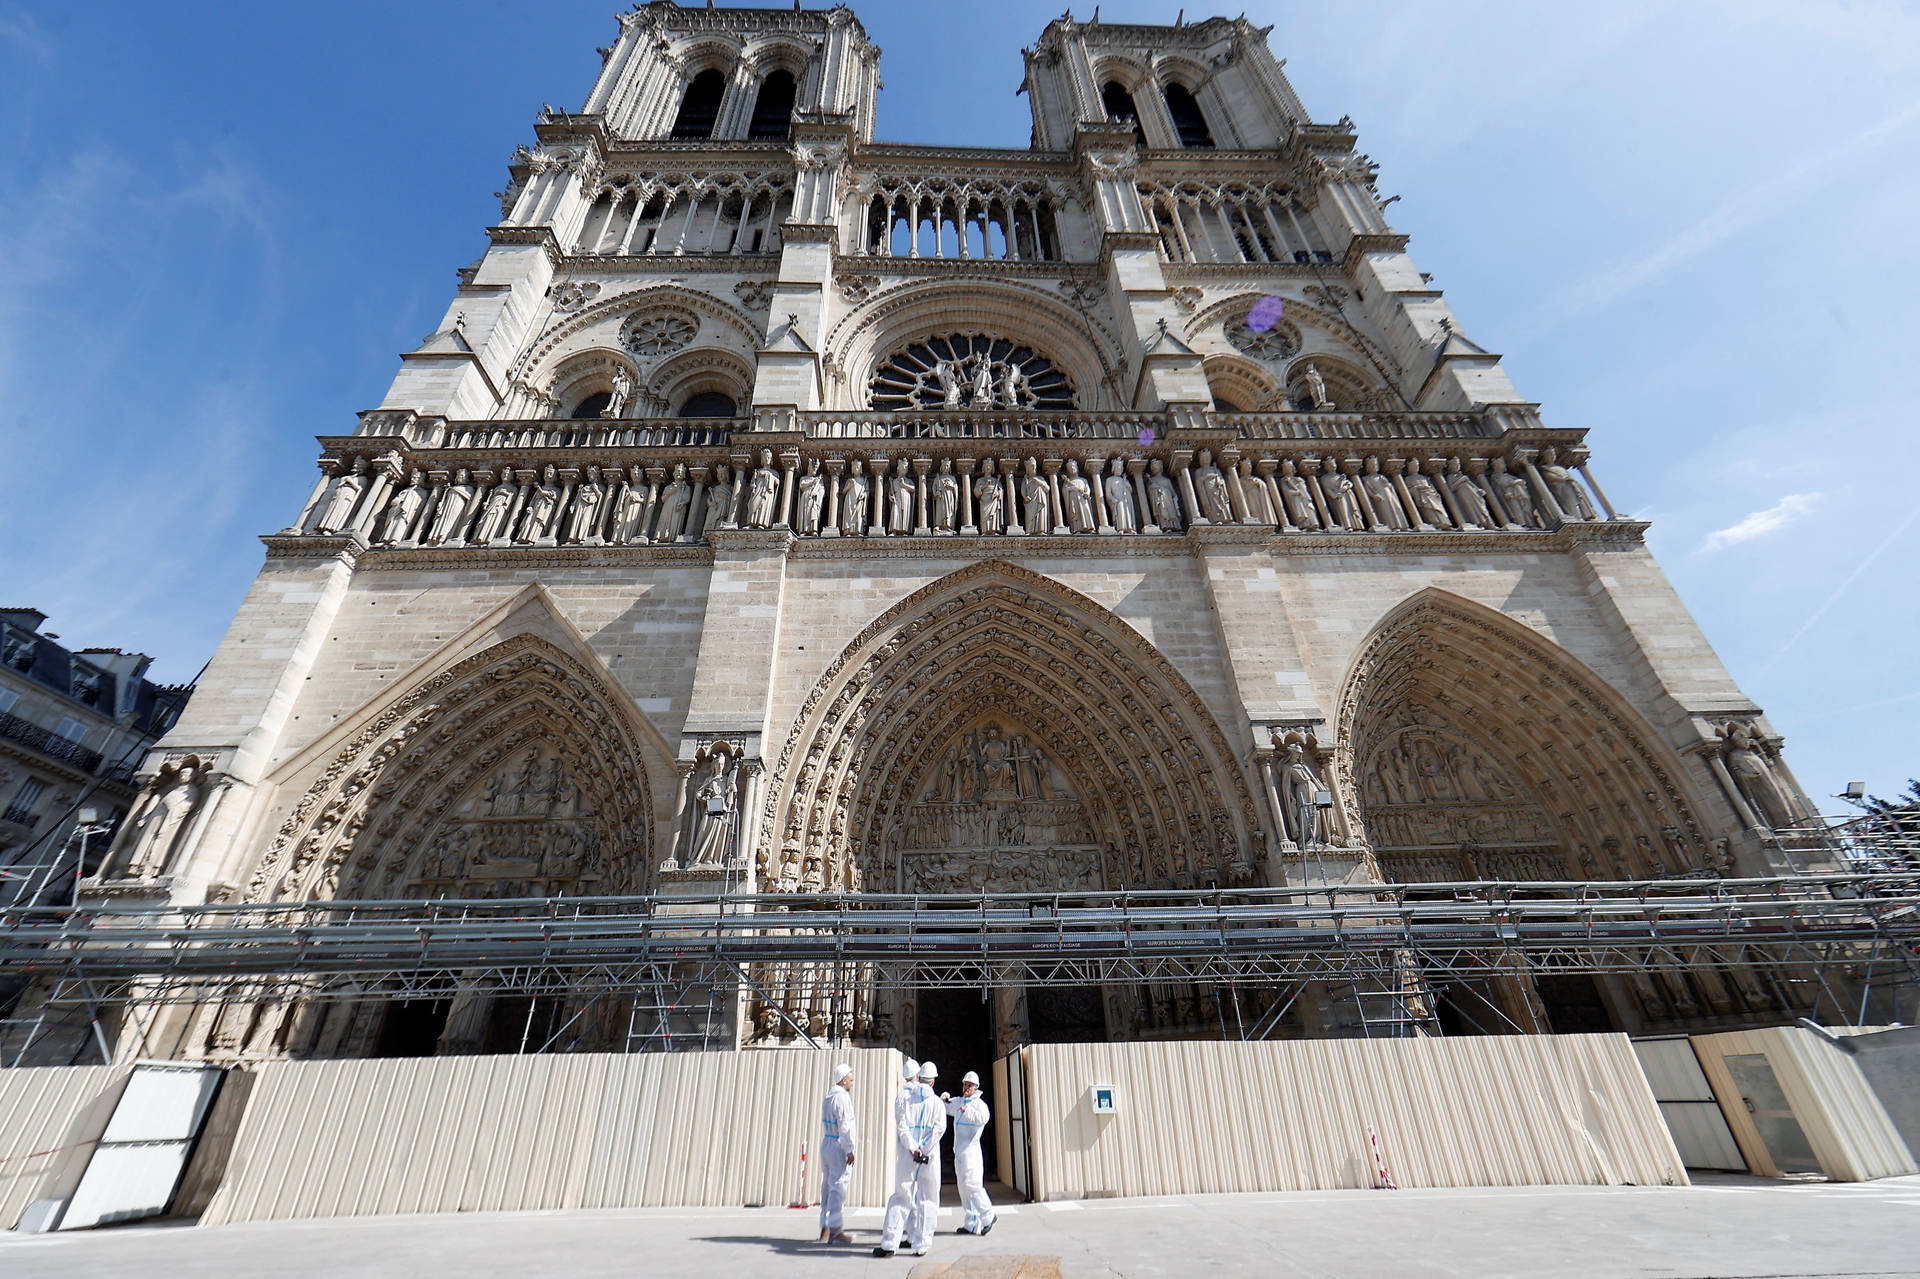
[192,634,660,1058]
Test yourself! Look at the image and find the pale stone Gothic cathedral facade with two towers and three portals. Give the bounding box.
[101,0,1811,1060]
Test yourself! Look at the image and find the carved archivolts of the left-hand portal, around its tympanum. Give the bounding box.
[246,636,653,901]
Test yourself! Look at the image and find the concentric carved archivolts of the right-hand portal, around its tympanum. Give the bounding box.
[1334,588,1709,878]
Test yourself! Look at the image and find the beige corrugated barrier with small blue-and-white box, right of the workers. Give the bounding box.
[1021,1035,1688,1200]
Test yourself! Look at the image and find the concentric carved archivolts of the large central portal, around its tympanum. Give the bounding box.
[756,561,1263,891]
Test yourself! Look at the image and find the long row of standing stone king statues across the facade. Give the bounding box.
[296,447,1599,547]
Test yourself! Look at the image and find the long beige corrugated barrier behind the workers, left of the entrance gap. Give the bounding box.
[202,1049,902,1225]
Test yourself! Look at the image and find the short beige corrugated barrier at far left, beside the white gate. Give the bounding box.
[0,1066,131,1229]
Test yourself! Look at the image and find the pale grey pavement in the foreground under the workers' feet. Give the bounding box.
[11,1177,1920,1279]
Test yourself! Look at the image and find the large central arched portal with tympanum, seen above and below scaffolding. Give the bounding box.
[755,561,1265,1052]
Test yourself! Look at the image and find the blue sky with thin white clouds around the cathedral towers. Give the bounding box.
[0,0,1920,795]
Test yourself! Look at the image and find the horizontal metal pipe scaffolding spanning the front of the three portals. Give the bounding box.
[0,870,1920,1060]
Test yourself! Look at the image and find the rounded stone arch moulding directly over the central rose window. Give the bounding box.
[824,280,1119,409]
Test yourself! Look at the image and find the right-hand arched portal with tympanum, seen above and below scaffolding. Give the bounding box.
[1334,590,1776,1033]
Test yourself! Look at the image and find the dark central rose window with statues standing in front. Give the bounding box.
[870,334,1073,411]
